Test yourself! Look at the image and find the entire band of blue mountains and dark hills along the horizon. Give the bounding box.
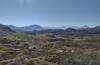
[0,24,100,34]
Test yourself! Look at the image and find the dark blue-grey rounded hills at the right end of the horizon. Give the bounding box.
[65,26,100,34]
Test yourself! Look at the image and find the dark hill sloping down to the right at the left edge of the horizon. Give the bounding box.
[0,24,14,35]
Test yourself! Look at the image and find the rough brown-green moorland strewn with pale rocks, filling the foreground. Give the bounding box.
[0,33,100,65]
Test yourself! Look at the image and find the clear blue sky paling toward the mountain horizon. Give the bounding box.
[0,0,100,27]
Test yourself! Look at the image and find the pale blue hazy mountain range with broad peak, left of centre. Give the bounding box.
[8,25,66,32]
